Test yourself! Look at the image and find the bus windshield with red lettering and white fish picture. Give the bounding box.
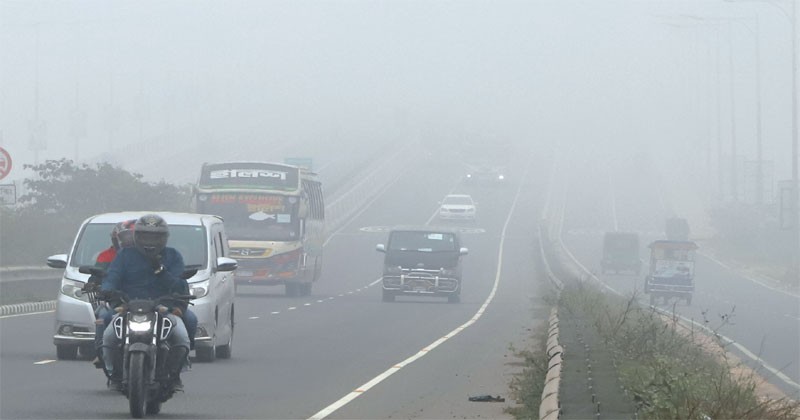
[198,193,300,241]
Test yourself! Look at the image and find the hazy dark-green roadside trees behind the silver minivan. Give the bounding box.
[0,159,192,265]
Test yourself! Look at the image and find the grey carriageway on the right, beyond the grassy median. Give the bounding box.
[563,153,800,395]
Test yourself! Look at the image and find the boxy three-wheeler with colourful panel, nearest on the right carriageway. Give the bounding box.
[644,240,697,305]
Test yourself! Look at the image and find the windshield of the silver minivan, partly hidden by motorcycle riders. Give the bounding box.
[69,223,208,269]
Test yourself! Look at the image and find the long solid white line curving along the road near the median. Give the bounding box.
[309,159,528,420]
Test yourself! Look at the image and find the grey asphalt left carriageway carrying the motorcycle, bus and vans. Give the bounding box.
[0,149,549,419]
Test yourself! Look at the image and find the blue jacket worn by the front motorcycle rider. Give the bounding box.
[101,247,189,308]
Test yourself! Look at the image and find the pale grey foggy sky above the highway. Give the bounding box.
[0,0,791,194]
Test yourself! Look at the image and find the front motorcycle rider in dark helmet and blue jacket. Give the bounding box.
[102,214,190,390]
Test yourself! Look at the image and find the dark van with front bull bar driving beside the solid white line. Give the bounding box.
[376,227,469,303]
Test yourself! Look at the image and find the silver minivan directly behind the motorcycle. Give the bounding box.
[47,211,236,362]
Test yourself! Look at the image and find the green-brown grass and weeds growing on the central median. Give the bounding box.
[507,284,800,420]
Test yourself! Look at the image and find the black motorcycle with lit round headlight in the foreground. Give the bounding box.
[79,266,197,418]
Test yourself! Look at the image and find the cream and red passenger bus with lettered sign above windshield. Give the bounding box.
[195,162,325,296]
